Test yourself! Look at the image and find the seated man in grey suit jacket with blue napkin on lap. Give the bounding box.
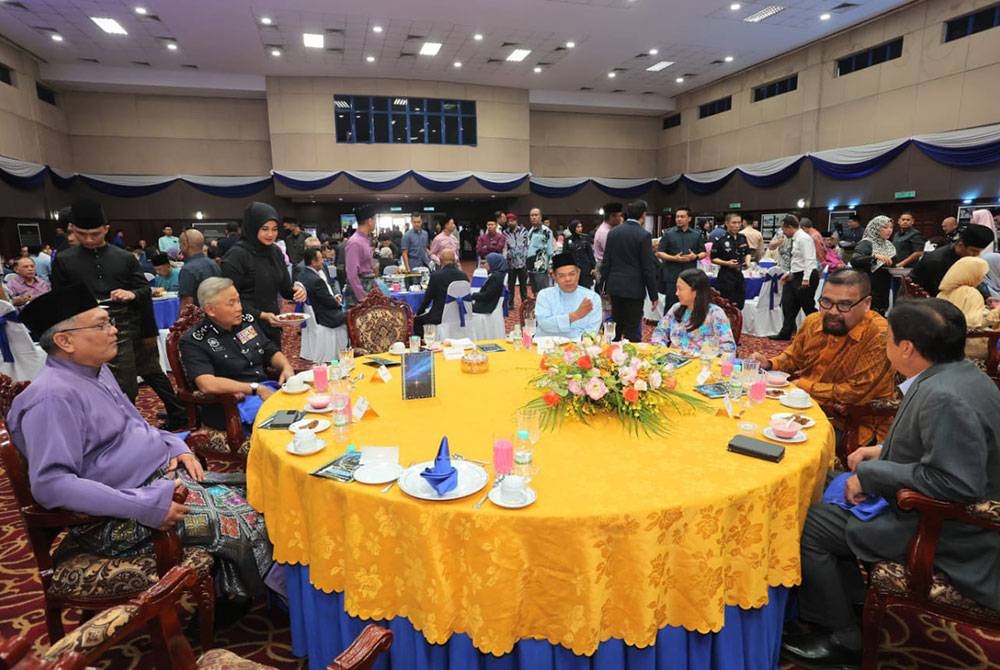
[783,298,1000,667]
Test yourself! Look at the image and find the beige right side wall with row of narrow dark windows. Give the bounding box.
[657,0,1000,175]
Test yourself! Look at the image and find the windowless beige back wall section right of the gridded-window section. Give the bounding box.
[531,112,660,178]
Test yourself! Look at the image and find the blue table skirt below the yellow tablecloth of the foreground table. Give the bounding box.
[285,565,789,670]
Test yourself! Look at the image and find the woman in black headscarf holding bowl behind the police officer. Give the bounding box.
[222,202,306,343]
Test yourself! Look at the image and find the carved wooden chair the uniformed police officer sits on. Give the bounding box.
[167,305,250,468]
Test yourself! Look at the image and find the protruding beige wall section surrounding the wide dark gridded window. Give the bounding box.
[267,77,529,172]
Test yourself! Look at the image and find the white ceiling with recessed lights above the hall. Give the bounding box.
[0,0,907,109]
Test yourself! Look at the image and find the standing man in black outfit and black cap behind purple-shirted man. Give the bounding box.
[52,200,188,430]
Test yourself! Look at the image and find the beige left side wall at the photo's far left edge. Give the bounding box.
[0,41,73,169]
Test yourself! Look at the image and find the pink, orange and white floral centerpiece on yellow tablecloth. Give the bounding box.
[526,336,707,435]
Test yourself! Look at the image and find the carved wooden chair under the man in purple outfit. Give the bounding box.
[0,421,215,645]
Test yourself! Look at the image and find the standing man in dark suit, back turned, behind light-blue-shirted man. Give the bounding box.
[597,200,659,342]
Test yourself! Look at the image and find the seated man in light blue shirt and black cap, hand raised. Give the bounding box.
[535,252,604,339]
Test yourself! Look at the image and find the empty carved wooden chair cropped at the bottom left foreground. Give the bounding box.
[0,567,392,670]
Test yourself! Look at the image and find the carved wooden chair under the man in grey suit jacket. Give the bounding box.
[862,489,1000,670]
